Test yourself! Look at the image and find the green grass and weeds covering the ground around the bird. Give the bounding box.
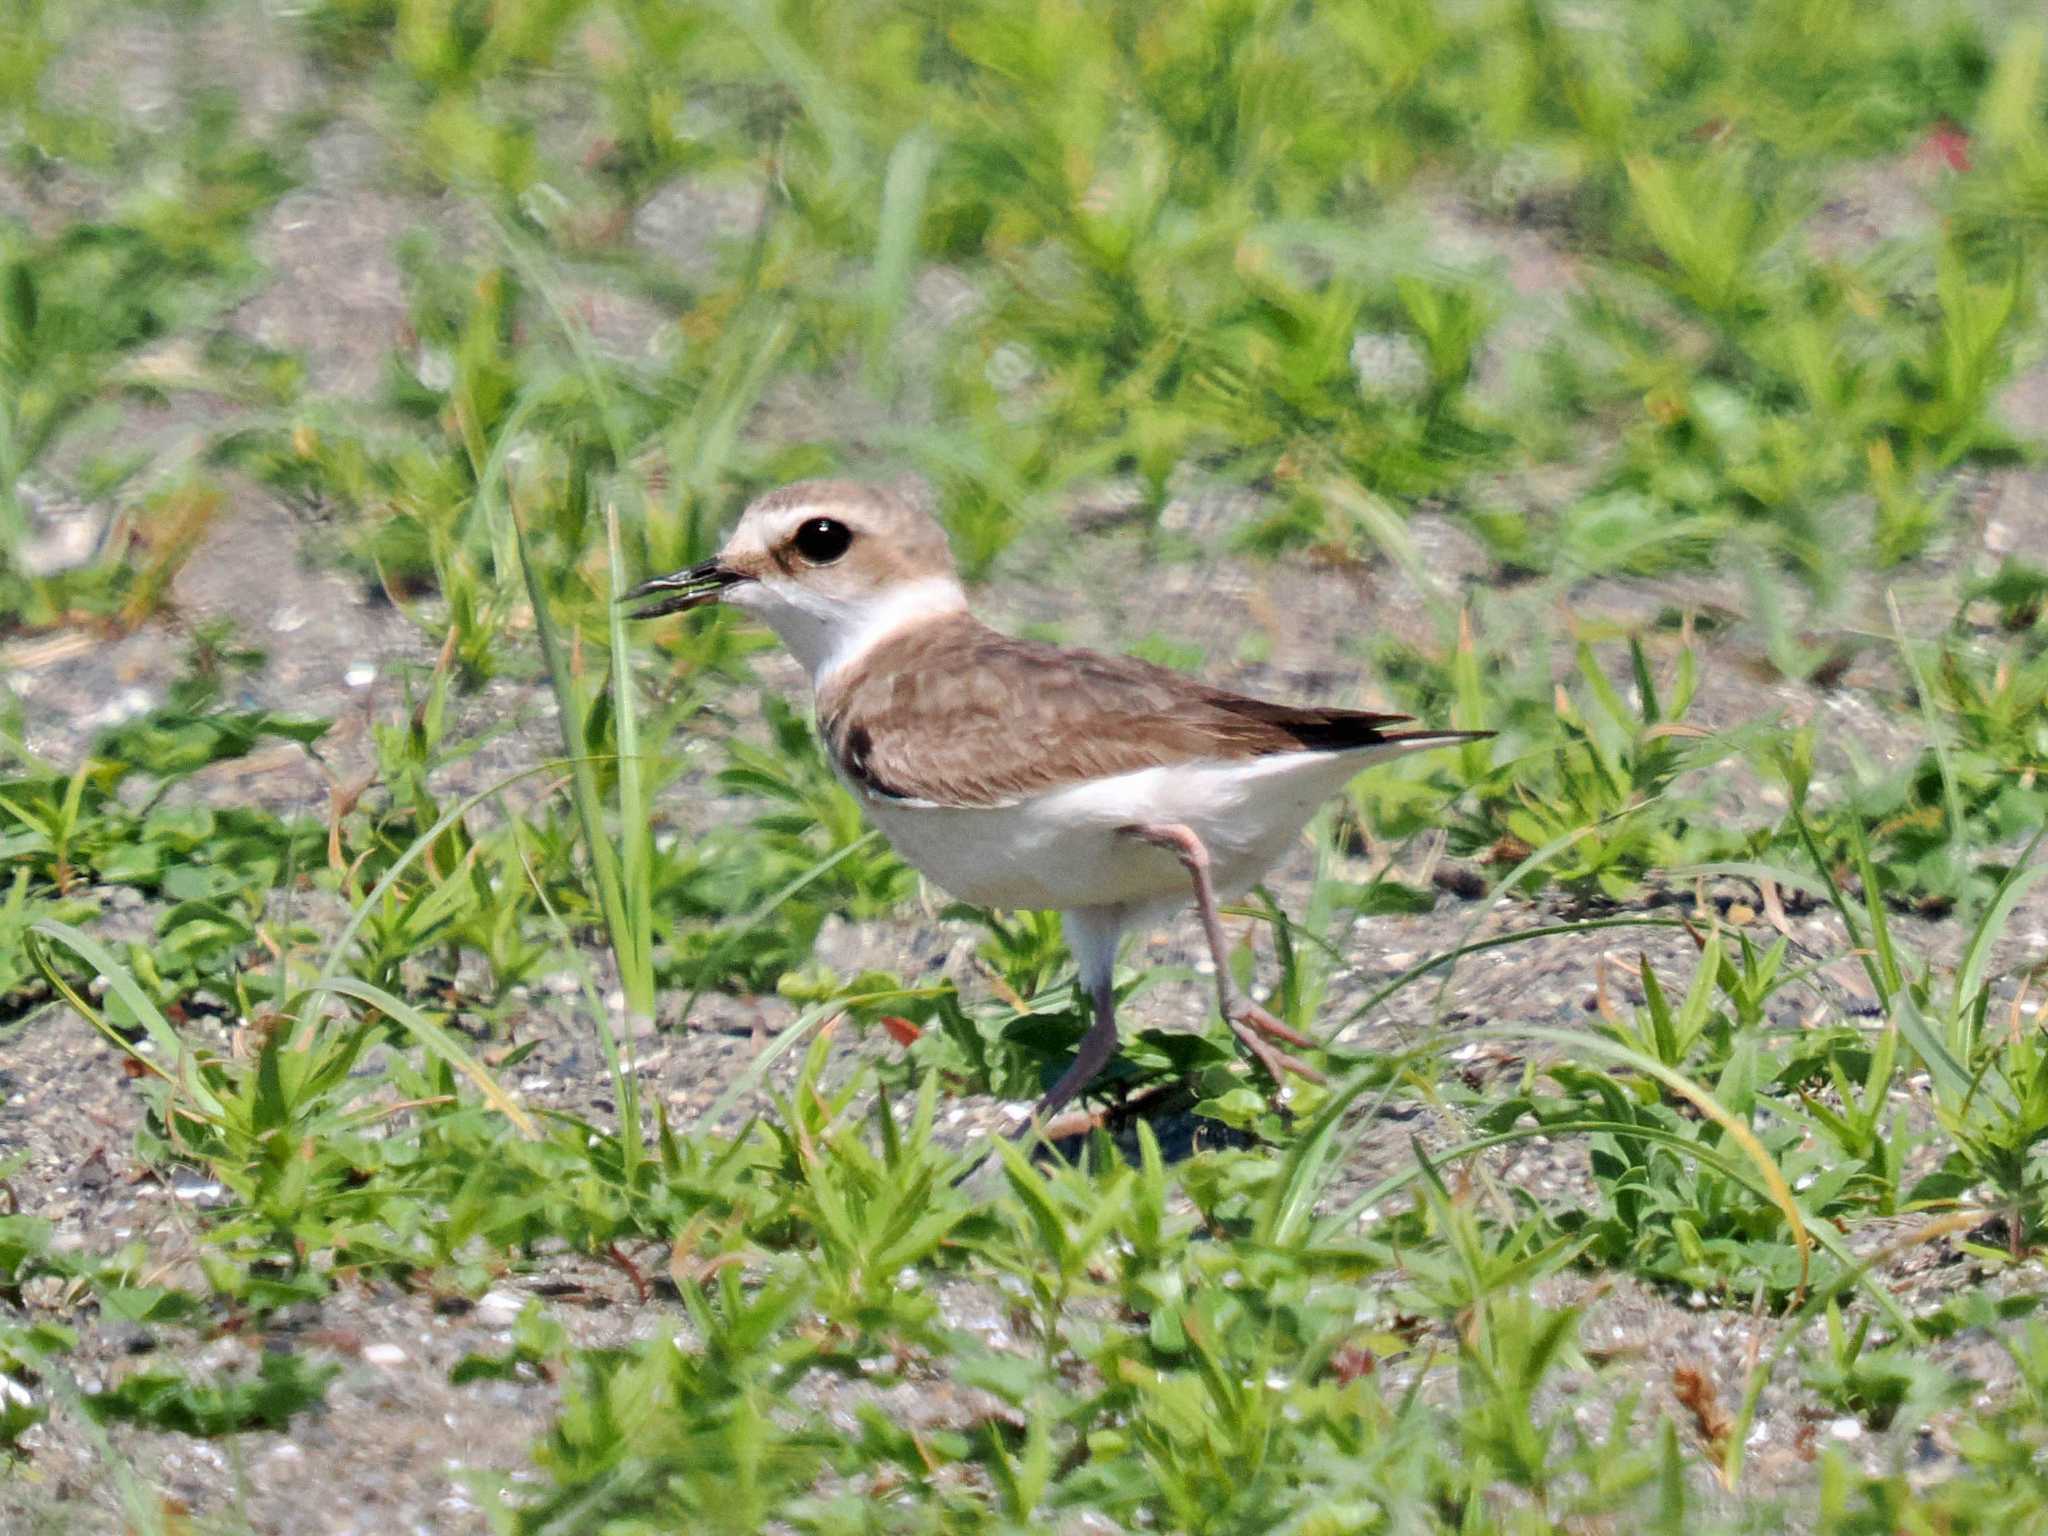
[0,0,2048,1536]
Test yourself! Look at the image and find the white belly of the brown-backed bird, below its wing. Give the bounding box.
[860,750,1384,911]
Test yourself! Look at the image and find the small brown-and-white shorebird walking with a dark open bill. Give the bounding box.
[627,479,1485,1120]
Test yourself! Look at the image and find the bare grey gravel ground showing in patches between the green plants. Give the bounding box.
[0,20,2048,1536]
